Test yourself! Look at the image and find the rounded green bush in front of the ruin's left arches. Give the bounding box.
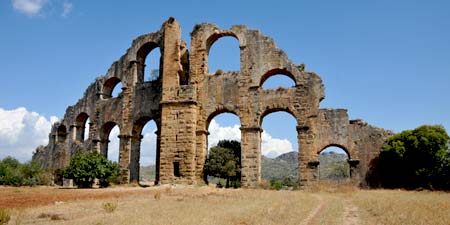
[63,152,119,188]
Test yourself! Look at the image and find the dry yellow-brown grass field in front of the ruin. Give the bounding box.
[0,185,450,225]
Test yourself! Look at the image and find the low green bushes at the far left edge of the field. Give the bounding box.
[0,156,51,186]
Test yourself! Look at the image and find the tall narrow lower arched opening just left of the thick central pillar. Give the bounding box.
[133,117,159,186]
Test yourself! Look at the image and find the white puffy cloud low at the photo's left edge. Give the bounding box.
[0,107,58,162]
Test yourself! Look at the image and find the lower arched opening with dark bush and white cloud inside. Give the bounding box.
[205,112,241,187]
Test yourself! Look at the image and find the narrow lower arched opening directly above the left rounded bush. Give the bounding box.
[101,122,120,162]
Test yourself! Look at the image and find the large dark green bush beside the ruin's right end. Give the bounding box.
[380,125,450,189]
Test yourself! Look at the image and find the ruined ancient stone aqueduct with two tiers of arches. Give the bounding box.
[33,18,390,187]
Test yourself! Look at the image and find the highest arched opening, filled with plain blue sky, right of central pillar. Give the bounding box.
[208,35,241,75]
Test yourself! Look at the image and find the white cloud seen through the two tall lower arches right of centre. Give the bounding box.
[208,120,294,158]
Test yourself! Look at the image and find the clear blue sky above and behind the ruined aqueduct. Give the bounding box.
[0,0,450,162]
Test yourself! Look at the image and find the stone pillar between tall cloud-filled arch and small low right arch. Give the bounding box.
[297,125,319,186]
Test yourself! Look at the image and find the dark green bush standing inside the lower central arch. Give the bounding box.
[204,140,241,187]
